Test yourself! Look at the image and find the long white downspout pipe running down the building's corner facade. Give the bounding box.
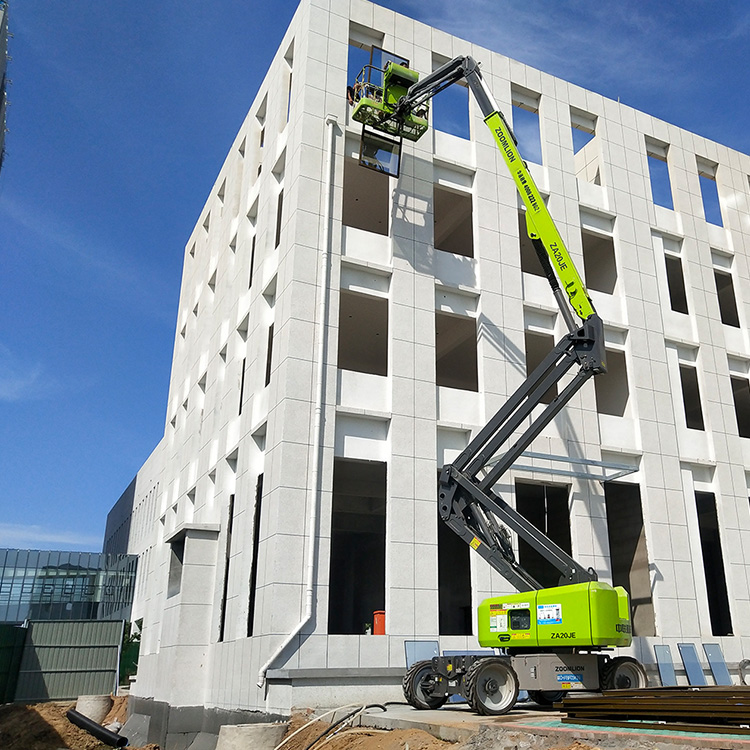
[258,115,338,688]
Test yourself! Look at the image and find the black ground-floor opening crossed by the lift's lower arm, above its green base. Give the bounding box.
[516,482,571,588]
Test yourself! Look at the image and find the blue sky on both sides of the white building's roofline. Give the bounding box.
[0,0,750,550]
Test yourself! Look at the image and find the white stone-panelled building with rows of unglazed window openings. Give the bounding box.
[105,0,750,713]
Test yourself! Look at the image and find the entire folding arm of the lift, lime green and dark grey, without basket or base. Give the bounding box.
[382,57,606,591]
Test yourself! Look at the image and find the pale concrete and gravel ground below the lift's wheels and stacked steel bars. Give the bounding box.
[358,704,750,750]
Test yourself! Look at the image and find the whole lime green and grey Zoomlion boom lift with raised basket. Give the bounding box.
[352,53,646,715]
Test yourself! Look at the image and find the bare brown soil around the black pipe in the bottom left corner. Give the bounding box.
[0,698,159,750]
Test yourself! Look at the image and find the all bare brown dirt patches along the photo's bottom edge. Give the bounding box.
[0,698,593,750]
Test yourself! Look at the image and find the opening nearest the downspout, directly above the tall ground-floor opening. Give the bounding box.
[339,289,388,375]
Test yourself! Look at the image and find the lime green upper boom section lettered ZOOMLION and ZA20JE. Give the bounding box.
[484,112,594,320]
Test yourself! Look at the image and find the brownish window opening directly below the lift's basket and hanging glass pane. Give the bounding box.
[341,159,389,235]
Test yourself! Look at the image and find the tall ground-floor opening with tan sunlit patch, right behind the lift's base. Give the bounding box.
[604,482,656,635]
